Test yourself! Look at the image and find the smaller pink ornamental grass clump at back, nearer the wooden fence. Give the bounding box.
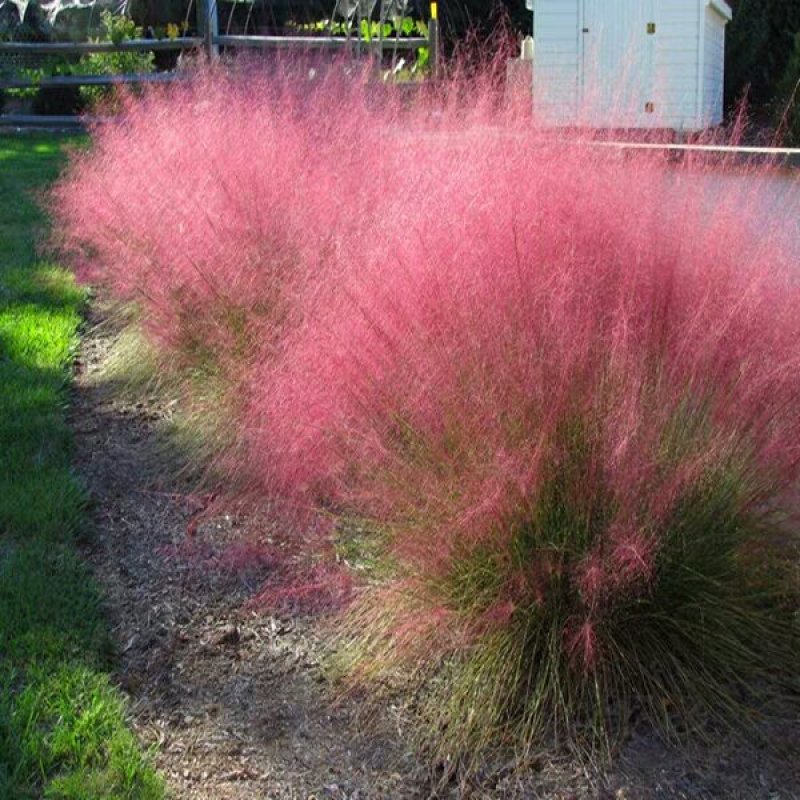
[52,59,396,468]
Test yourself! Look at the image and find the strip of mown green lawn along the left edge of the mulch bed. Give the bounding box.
[0,136,164,800]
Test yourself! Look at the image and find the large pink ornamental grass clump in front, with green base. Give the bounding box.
[250,124,800,761]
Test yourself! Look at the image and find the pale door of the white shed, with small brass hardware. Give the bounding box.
[581,0,658,127]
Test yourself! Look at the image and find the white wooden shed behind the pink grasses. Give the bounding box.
[528,0,731,131]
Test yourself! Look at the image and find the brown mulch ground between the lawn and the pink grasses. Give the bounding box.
[72,306,800,800]
